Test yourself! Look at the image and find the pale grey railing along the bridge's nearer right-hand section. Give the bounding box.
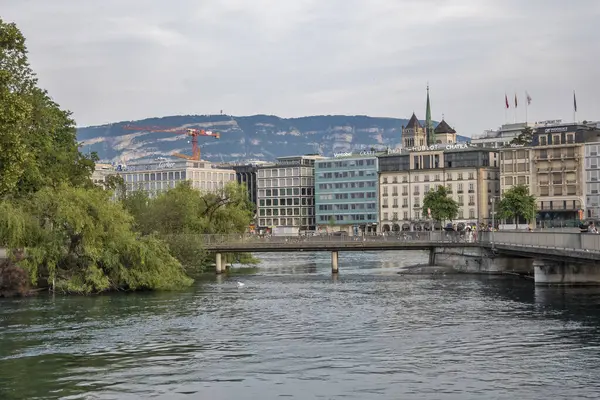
[479,231,600,252]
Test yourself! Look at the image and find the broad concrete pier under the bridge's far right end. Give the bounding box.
[533,259,600,286]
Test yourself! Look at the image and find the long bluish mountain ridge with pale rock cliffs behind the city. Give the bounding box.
[77,115,468,162]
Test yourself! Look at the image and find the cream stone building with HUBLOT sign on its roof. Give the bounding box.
[379,144,500,232]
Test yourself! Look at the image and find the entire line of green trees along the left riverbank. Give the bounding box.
[0,19,253,296]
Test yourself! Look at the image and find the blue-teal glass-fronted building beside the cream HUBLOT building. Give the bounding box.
[315,151,379,235]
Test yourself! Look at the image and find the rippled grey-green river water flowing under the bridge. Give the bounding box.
[0,252,600,400]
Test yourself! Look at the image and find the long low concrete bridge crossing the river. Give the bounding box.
[202,231,600,284]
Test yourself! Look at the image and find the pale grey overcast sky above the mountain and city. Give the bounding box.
[0,0,600,136]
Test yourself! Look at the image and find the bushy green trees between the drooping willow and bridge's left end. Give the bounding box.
[123,181,254,273]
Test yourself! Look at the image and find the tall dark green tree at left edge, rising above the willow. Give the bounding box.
[0,19,94,196]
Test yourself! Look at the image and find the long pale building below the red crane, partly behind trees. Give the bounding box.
[116,157,236,195]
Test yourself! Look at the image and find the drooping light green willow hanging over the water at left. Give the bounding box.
[0,185,191,293]
